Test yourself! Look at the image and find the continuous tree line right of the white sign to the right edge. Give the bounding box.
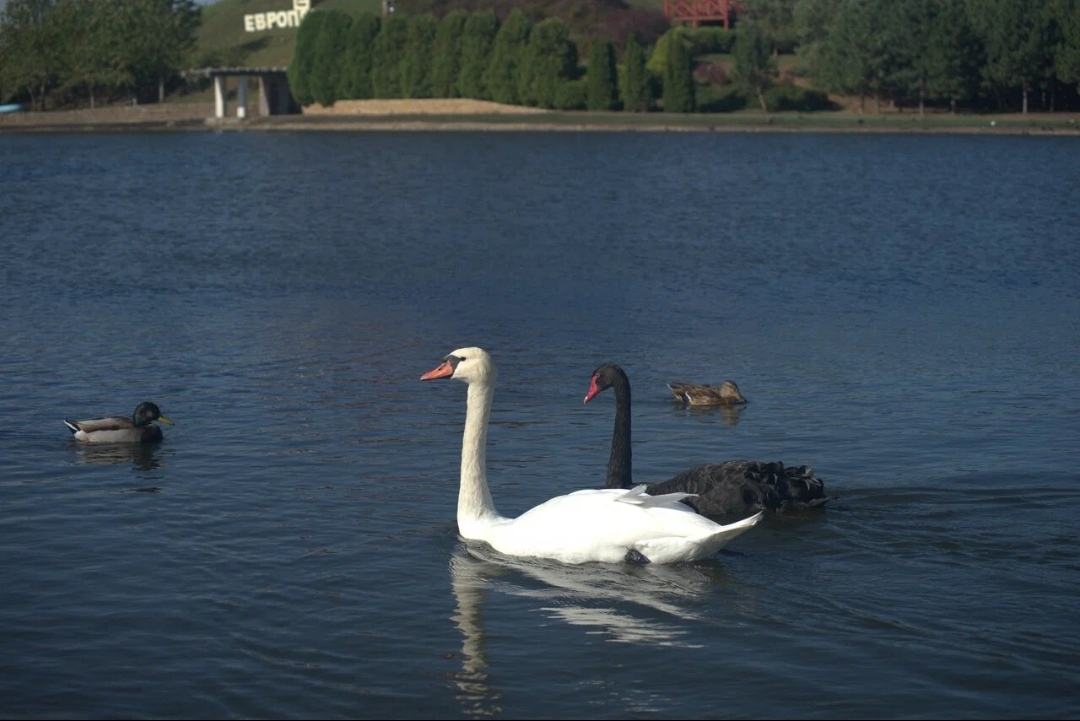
[289,0,1080,112]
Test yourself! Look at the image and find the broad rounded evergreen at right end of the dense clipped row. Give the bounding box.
[517,17,578,108]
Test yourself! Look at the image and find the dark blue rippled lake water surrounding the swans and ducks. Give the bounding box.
[0,132,1080,719]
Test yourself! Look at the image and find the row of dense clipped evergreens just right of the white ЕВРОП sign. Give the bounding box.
[288,10,669,109]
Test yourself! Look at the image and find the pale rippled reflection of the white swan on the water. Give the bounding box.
[450,542,742,717]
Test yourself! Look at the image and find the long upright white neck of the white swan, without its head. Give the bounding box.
[458,380,505,541]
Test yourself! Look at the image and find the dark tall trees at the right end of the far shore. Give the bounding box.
[794,0,1080,112]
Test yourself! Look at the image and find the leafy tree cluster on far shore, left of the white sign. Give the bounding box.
[0,0,200,110]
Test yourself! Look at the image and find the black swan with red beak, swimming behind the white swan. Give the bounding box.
[585,364,833,523]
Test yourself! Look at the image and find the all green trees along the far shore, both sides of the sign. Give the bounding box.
[0,0,1080,112]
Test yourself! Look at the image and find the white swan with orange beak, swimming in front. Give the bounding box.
[420,348,761,563]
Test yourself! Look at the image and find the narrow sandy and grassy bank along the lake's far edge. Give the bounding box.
[0,100,1080,137]
